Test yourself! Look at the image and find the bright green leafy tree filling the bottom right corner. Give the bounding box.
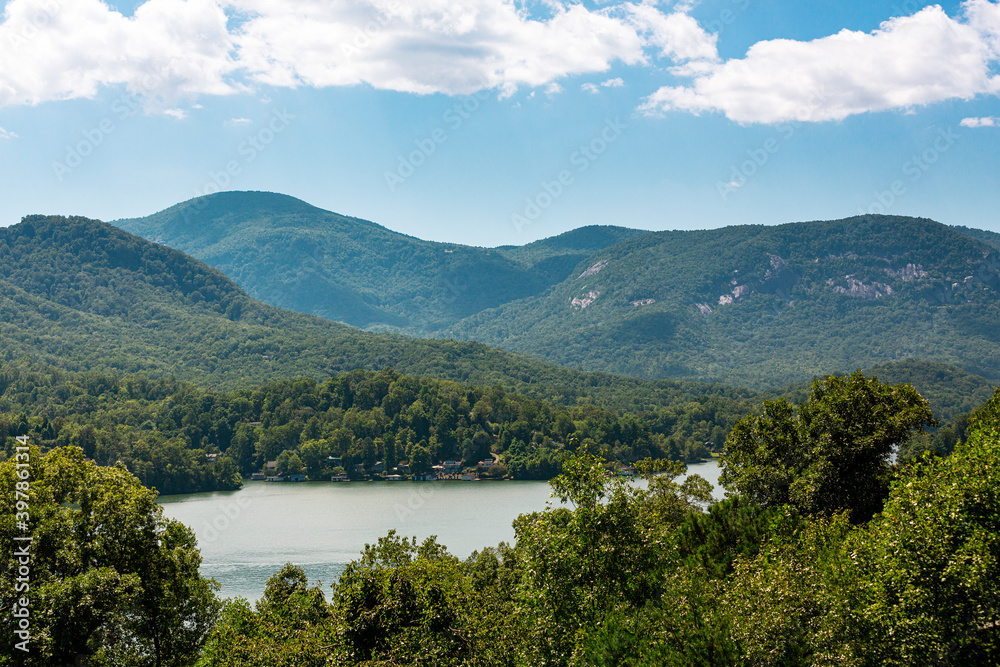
[852,390,1000,666]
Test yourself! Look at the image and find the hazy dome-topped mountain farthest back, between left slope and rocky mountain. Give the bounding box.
[114,192,645,335]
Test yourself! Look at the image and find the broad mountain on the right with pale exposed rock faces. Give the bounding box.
[441,216,1000,388]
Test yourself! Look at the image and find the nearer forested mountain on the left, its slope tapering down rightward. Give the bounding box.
[0,216,750,410]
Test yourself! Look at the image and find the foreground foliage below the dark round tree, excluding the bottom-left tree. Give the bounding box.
[201,380,1000,667]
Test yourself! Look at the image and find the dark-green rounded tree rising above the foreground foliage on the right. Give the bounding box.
[719,371,937,524]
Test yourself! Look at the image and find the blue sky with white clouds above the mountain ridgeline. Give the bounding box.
[0,0,1000,246]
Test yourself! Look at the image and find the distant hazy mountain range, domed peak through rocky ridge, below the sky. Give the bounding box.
[116,192,1000,388]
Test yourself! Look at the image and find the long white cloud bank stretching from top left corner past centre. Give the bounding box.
[0,0,716,109]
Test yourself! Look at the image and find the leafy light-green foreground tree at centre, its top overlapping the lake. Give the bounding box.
[514,448,710,665]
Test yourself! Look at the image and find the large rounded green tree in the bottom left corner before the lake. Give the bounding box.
[0,447,219,667]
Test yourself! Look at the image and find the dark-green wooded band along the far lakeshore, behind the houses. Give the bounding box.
[0,363,751,494]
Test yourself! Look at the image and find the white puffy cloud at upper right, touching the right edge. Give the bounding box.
[640,0,1000,123]
